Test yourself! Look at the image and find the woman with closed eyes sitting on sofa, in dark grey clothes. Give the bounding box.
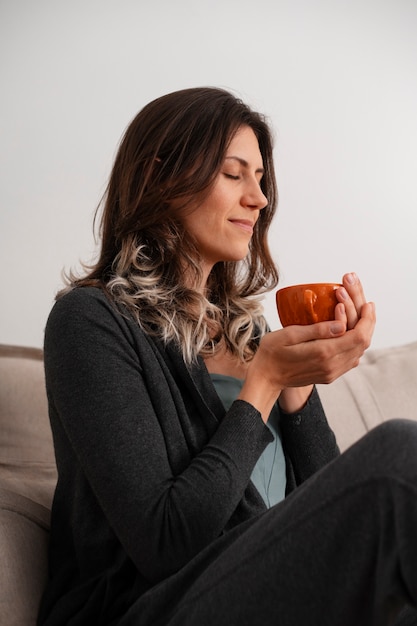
[39,88,417,626]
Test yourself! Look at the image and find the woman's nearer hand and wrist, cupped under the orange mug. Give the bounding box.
[239,302,375,422]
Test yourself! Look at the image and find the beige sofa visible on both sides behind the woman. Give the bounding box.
[0,342,417,626]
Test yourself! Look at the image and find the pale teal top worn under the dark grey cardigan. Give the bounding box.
[210,374,287,508]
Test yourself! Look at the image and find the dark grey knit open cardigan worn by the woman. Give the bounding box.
[39,288,338,625]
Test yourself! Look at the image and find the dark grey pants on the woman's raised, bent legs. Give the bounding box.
[127,420,417,626]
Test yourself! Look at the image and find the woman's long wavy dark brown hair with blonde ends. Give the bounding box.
[57,87,278,362]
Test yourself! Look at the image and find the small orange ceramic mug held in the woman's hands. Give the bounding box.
[276,283,342,327]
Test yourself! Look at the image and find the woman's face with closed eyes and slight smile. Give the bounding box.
[181,126,267,278]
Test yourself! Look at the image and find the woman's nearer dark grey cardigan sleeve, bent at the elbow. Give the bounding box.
[45,288,270,582]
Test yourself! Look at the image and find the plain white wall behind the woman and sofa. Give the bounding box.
[0,0,417,347]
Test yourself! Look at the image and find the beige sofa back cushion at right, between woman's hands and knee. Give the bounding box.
[318,342,417,450]
